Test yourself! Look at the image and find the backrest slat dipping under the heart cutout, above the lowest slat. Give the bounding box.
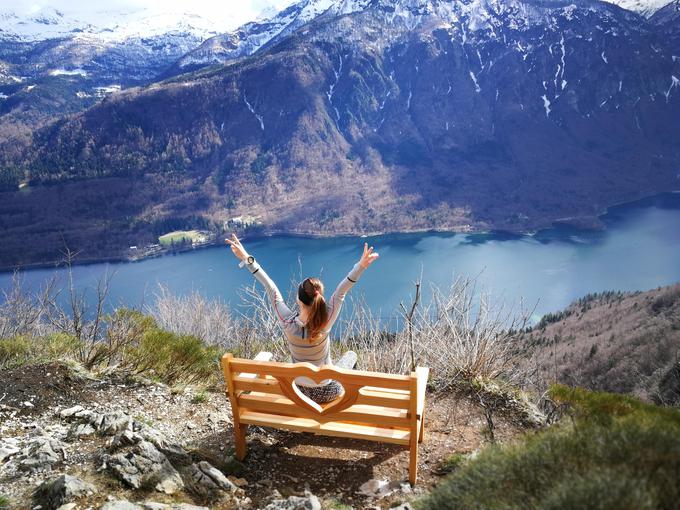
[238,393,410,429]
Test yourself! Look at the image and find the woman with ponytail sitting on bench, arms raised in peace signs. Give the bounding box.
[226,234,378,404]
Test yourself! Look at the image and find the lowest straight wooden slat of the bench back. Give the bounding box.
[241,410,411,445]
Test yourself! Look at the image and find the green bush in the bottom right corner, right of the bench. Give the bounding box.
[417,386,680,510]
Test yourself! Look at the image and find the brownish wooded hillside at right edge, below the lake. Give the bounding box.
[519,284,680,406]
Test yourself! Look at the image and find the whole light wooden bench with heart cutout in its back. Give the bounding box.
[222,353,429,485]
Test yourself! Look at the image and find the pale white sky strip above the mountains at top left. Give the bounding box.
[0,0,293,27]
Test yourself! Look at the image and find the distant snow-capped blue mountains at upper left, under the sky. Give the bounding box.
[0,8,226,144]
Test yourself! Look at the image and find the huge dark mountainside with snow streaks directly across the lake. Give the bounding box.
[2,0,680,270]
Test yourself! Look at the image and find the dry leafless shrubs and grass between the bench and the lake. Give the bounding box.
[0,270,527,389]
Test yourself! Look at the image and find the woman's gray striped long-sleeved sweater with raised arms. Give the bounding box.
[246,261,364,386]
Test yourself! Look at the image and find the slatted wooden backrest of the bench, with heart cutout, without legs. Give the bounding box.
[222,354,418,429]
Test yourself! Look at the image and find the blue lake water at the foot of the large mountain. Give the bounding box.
[0,193,680,321]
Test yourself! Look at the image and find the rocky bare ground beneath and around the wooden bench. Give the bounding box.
[0,364,525,510]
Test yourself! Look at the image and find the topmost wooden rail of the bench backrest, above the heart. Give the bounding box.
[229,359,410,390]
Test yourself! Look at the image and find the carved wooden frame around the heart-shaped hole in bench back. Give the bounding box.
[274,369,363,416]
